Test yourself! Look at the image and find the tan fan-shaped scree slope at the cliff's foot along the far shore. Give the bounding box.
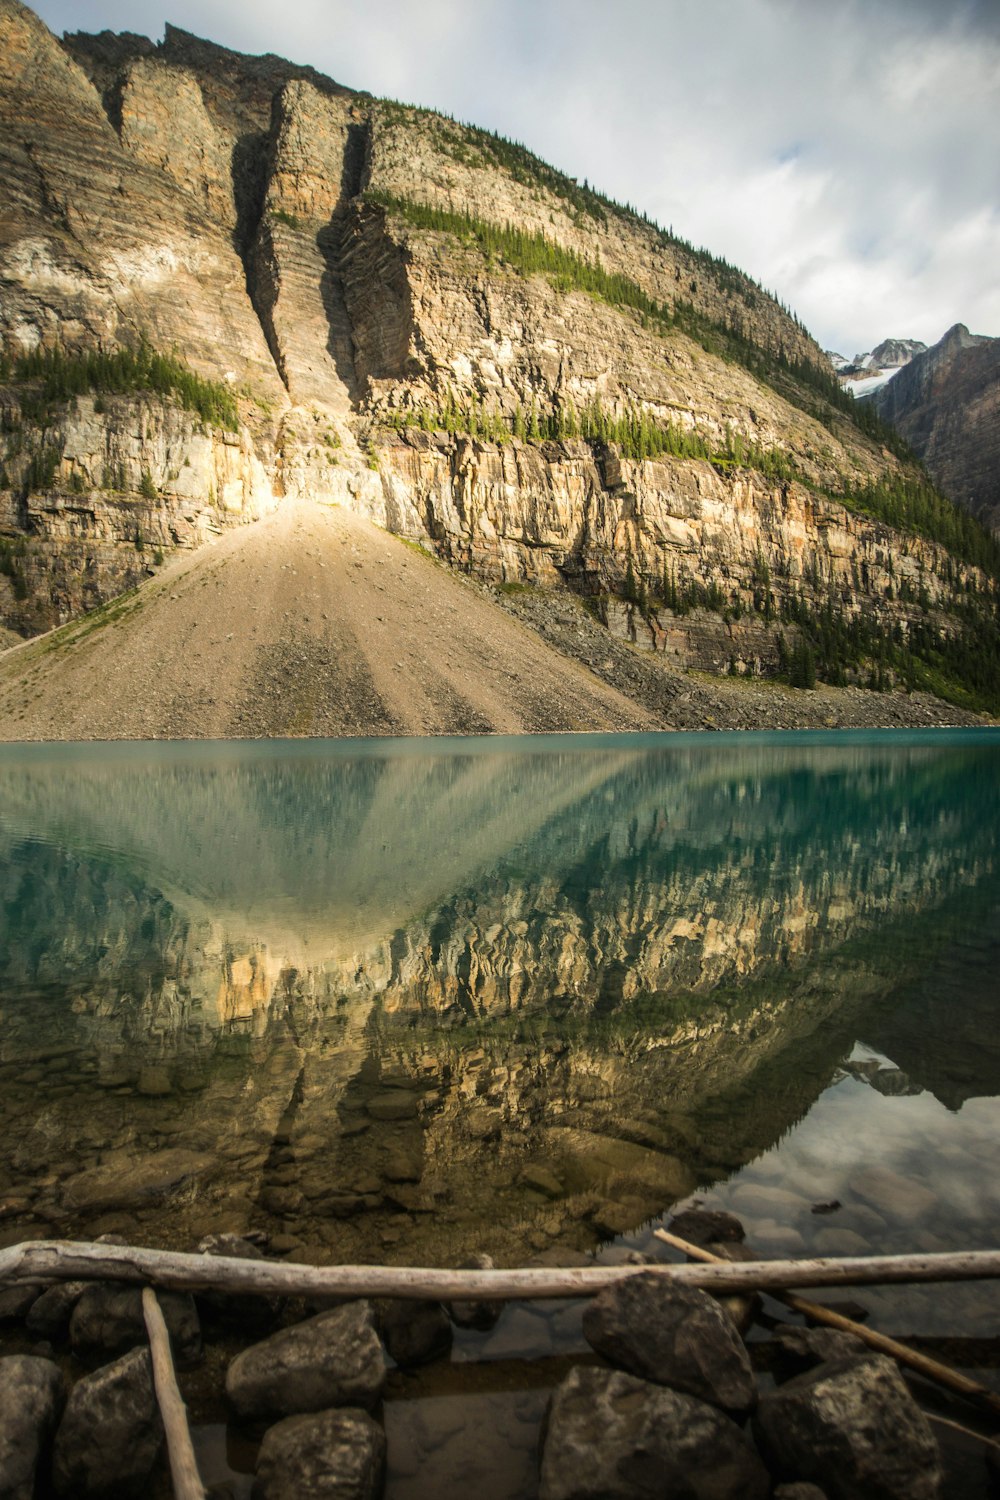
[0,503,981,740]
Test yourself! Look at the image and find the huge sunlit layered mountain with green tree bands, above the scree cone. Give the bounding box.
[0,0,1000,729]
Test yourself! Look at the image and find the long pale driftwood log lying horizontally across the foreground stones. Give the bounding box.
[0,1239,1000,1302]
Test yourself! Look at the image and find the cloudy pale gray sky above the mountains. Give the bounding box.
[34,0,1000,356]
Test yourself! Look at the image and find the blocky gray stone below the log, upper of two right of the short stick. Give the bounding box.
[226,1302,385,1416]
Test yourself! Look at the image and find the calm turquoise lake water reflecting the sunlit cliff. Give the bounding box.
[0,731,1000,1497]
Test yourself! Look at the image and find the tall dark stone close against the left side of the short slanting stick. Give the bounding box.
[52,1349,163,1500]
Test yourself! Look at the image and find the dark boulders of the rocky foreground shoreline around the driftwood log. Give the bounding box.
[0,1208,1000,1500]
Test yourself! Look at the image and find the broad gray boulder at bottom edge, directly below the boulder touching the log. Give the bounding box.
[538,1367,771,1500]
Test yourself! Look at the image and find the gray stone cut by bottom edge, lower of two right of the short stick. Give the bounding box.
[253,1407,385,1500]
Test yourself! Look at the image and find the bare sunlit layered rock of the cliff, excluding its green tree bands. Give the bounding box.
[0,0,975,671]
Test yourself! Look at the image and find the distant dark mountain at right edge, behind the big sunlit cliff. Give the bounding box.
[873,323,1000,531]
